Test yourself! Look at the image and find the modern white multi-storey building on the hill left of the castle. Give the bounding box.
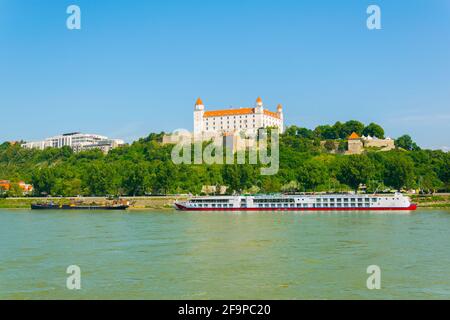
[22,132,125,153]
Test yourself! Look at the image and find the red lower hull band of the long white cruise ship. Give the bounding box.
[175,203,417,211]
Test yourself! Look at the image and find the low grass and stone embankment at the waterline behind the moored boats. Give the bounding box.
[0,194,450,210]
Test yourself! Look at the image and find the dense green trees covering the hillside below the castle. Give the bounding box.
[0,121,450,197]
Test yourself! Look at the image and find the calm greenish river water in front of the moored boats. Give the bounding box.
[0,209,450,299]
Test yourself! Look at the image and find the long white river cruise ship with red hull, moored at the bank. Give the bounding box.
[175,193,417,211]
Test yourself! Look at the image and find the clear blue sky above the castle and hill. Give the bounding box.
[0,0,450,148]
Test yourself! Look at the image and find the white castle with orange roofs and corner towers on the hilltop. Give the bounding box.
[194,98,284,136]
